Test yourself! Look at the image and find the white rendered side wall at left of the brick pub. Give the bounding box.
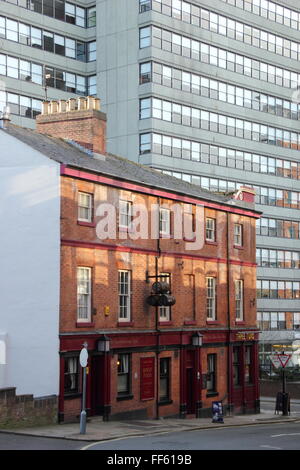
[0,129,60,396]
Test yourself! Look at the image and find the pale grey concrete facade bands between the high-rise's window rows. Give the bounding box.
[1,0,300,364]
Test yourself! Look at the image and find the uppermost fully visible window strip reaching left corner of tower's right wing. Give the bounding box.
[140,26,300,88]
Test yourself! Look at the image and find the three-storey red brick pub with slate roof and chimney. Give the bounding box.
[0,99,260,421]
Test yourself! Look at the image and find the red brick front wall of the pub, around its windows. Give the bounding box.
[60,177,256,417]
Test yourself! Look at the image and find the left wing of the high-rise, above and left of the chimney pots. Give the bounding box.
[0,0,97,127]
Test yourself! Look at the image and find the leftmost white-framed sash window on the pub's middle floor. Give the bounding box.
[77,267,92,322]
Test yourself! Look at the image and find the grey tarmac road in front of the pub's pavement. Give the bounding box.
[0,422,300,452]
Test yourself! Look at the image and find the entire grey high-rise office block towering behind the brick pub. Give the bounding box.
[0,0,300,366]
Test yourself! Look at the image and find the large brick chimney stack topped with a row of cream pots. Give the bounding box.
[36,96,106,154]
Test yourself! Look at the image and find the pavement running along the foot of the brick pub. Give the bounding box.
[0,397,300,442]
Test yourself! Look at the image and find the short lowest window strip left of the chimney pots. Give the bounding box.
[0,91,42,119]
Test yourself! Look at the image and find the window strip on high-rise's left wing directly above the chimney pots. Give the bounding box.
[0,54,96,95]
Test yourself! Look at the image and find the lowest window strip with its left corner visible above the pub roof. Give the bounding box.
[140,136,300,179]
